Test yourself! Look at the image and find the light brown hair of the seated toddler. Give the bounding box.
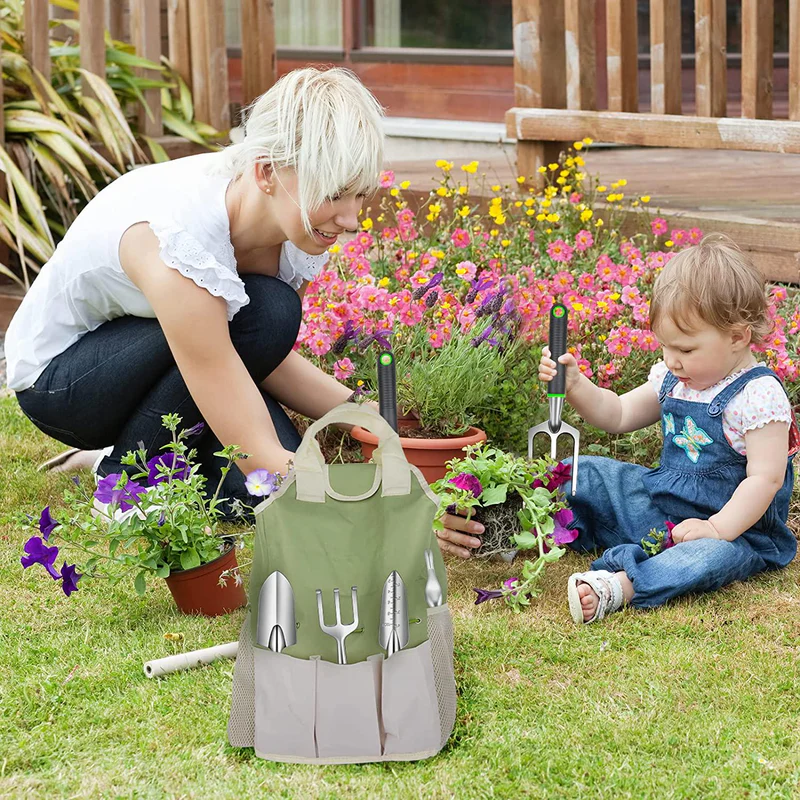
[650,234,773,344]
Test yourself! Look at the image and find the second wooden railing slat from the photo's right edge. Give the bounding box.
[742,0,775,119]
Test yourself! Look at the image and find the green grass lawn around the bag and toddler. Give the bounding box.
[0,398,800,799]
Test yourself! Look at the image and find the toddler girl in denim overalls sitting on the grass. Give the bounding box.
[539,236,800,623]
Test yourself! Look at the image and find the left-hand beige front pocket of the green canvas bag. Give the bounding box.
[253,647,317,758]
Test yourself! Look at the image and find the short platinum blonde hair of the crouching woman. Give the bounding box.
[218,67,383,233]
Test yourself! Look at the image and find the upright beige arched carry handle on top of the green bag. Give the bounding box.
[294,403,411,503]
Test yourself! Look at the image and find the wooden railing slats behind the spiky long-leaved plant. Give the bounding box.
[19,0,276,136]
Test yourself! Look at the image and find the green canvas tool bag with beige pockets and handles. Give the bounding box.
[228,403,456,763]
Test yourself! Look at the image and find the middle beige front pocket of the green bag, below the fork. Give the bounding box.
[316,657,382,758]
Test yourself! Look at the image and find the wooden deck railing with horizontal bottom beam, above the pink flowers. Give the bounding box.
[506,0,800,176]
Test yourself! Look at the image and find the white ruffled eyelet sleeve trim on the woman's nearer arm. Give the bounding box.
[150,222,250,322]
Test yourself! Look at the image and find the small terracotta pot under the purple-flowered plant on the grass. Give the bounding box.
[166,544,247,617]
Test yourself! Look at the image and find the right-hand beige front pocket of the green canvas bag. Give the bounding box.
[382,641,441,756]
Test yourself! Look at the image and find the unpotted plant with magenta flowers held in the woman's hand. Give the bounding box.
[432,443,578,611]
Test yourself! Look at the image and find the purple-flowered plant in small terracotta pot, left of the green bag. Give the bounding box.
[21,414,280,616]
